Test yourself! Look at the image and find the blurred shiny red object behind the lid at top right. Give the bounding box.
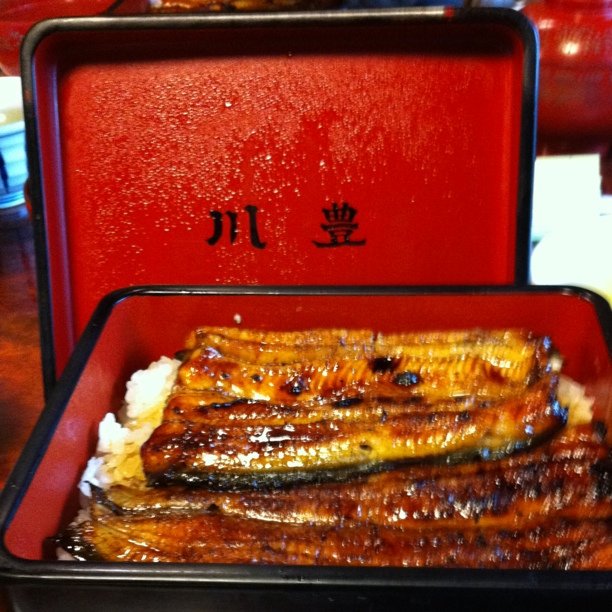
[523,0,612,193]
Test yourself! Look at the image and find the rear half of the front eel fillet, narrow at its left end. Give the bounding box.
[99,426,612,529]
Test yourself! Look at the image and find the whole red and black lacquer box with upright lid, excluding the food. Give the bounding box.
[0,8,612,611]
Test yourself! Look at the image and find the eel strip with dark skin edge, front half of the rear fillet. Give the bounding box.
[141,378,566,489]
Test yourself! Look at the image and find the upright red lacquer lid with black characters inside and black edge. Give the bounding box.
[22,8,537,382]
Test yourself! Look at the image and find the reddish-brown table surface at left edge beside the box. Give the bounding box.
[0,209,44,612]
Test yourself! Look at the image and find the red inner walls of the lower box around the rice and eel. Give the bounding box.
[4,290,612,560]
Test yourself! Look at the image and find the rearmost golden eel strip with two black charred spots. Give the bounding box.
[178,328,559,404]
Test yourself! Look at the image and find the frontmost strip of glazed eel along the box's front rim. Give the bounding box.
[60,513,612,570]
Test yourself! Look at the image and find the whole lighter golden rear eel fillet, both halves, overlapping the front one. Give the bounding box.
[141,328,566,489]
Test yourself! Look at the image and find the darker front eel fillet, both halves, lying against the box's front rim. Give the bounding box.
[58,425,612,569]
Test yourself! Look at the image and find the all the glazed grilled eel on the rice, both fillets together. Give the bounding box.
[56,328,612,569]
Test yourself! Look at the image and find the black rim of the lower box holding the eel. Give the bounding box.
[0,285,612,592]
